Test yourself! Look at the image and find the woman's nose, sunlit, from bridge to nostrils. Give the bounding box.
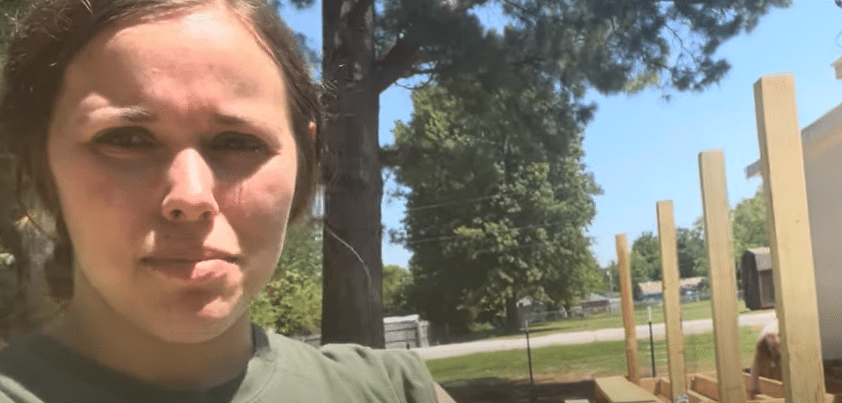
[161,149,219,221]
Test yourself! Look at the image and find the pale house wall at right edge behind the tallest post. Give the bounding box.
[746,97,842,360]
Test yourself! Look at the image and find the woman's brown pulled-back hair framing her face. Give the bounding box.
[0,0,322,299]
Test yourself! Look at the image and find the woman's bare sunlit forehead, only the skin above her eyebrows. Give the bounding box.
[61,7,284,107]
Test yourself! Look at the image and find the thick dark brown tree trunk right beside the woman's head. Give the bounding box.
[322,0,385,348]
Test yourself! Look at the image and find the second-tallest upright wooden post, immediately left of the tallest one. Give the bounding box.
[699,150,748,403]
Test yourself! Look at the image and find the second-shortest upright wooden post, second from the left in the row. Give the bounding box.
[657,200,687,402]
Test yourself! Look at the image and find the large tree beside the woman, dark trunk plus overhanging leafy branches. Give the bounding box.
[300,0,780,347]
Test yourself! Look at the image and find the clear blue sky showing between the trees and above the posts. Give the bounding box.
[282,0,842,267]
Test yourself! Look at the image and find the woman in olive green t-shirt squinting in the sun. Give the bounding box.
[0,0,452,402]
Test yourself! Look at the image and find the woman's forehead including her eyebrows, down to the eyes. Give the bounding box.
[55,3,289,134]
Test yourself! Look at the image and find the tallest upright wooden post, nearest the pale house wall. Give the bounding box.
[754,75,825,402]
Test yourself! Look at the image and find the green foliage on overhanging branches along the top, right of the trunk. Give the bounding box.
[375,0,791,94]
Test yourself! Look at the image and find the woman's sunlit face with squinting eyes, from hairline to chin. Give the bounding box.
[47,7,297,343]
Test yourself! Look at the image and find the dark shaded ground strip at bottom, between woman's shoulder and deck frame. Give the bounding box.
[442,377,594,403]
